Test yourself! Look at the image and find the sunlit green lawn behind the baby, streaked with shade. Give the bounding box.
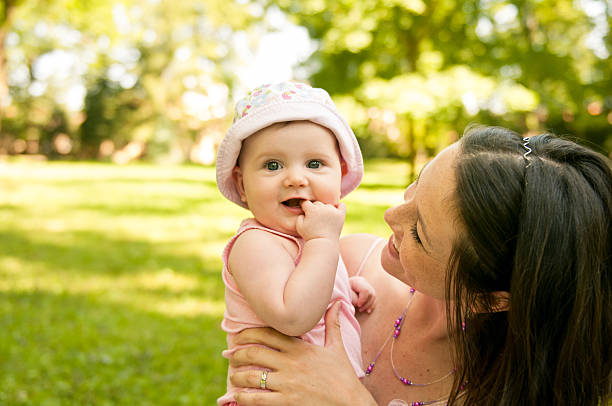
[0,157,406,406]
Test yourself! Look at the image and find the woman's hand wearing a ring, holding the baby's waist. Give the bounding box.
[230,302,376,406]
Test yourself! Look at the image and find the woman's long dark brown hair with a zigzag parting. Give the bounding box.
[446,127,612,406]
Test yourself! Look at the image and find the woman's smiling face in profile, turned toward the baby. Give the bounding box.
[381,143,459,299]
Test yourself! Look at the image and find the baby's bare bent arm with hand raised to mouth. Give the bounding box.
[229,201,345,336]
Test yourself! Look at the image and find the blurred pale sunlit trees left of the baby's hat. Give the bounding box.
[4,0,266,158]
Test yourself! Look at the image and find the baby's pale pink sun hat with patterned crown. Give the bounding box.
[216,82,363,208]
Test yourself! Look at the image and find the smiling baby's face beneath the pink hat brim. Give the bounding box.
[234,121,342,235]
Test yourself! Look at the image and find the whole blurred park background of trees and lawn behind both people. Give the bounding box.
[0,0,612,406]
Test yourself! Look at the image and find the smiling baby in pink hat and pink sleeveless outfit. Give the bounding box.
[217,82,375,405]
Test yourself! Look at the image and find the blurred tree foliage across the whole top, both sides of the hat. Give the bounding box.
[0,0,612,167]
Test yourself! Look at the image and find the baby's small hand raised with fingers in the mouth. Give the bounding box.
[295,200,346,241]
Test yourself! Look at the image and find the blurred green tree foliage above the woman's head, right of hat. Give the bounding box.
[267,0,612,173]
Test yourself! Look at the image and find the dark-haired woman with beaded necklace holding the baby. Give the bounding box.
[226,127,612,406]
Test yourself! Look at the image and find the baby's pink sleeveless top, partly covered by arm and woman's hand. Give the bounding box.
[217,219,364,406]
